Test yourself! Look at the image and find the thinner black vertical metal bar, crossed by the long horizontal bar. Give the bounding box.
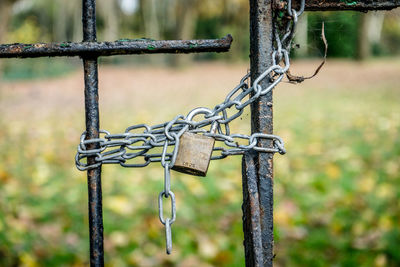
[82,0,104,267]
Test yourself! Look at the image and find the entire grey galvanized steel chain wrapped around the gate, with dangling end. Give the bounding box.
[75,0,305,254]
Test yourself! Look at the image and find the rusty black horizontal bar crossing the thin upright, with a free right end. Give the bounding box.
[0,34,232,58]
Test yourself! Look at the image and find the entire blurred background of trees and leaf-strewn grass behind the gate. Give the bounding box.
[0,0,400,267]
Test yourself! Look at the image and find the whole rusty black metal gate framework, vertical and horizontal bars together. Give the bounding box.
[0,0,400,266]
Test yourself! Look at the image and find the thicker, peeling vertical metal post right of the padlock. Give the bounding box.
[243,0,274,266]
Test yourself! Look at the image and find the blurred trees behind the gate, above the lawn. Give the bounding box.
[0,0,400,79]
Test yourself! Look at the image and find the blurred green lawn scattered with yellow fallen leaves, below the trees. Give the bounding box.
[0,59,400,267]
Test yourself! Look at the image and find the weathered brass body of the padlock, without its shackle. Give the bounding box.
[172,132,215,176]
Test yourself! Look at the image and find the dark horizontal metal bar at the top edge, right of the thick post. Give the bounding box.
[275,0,400,11]
